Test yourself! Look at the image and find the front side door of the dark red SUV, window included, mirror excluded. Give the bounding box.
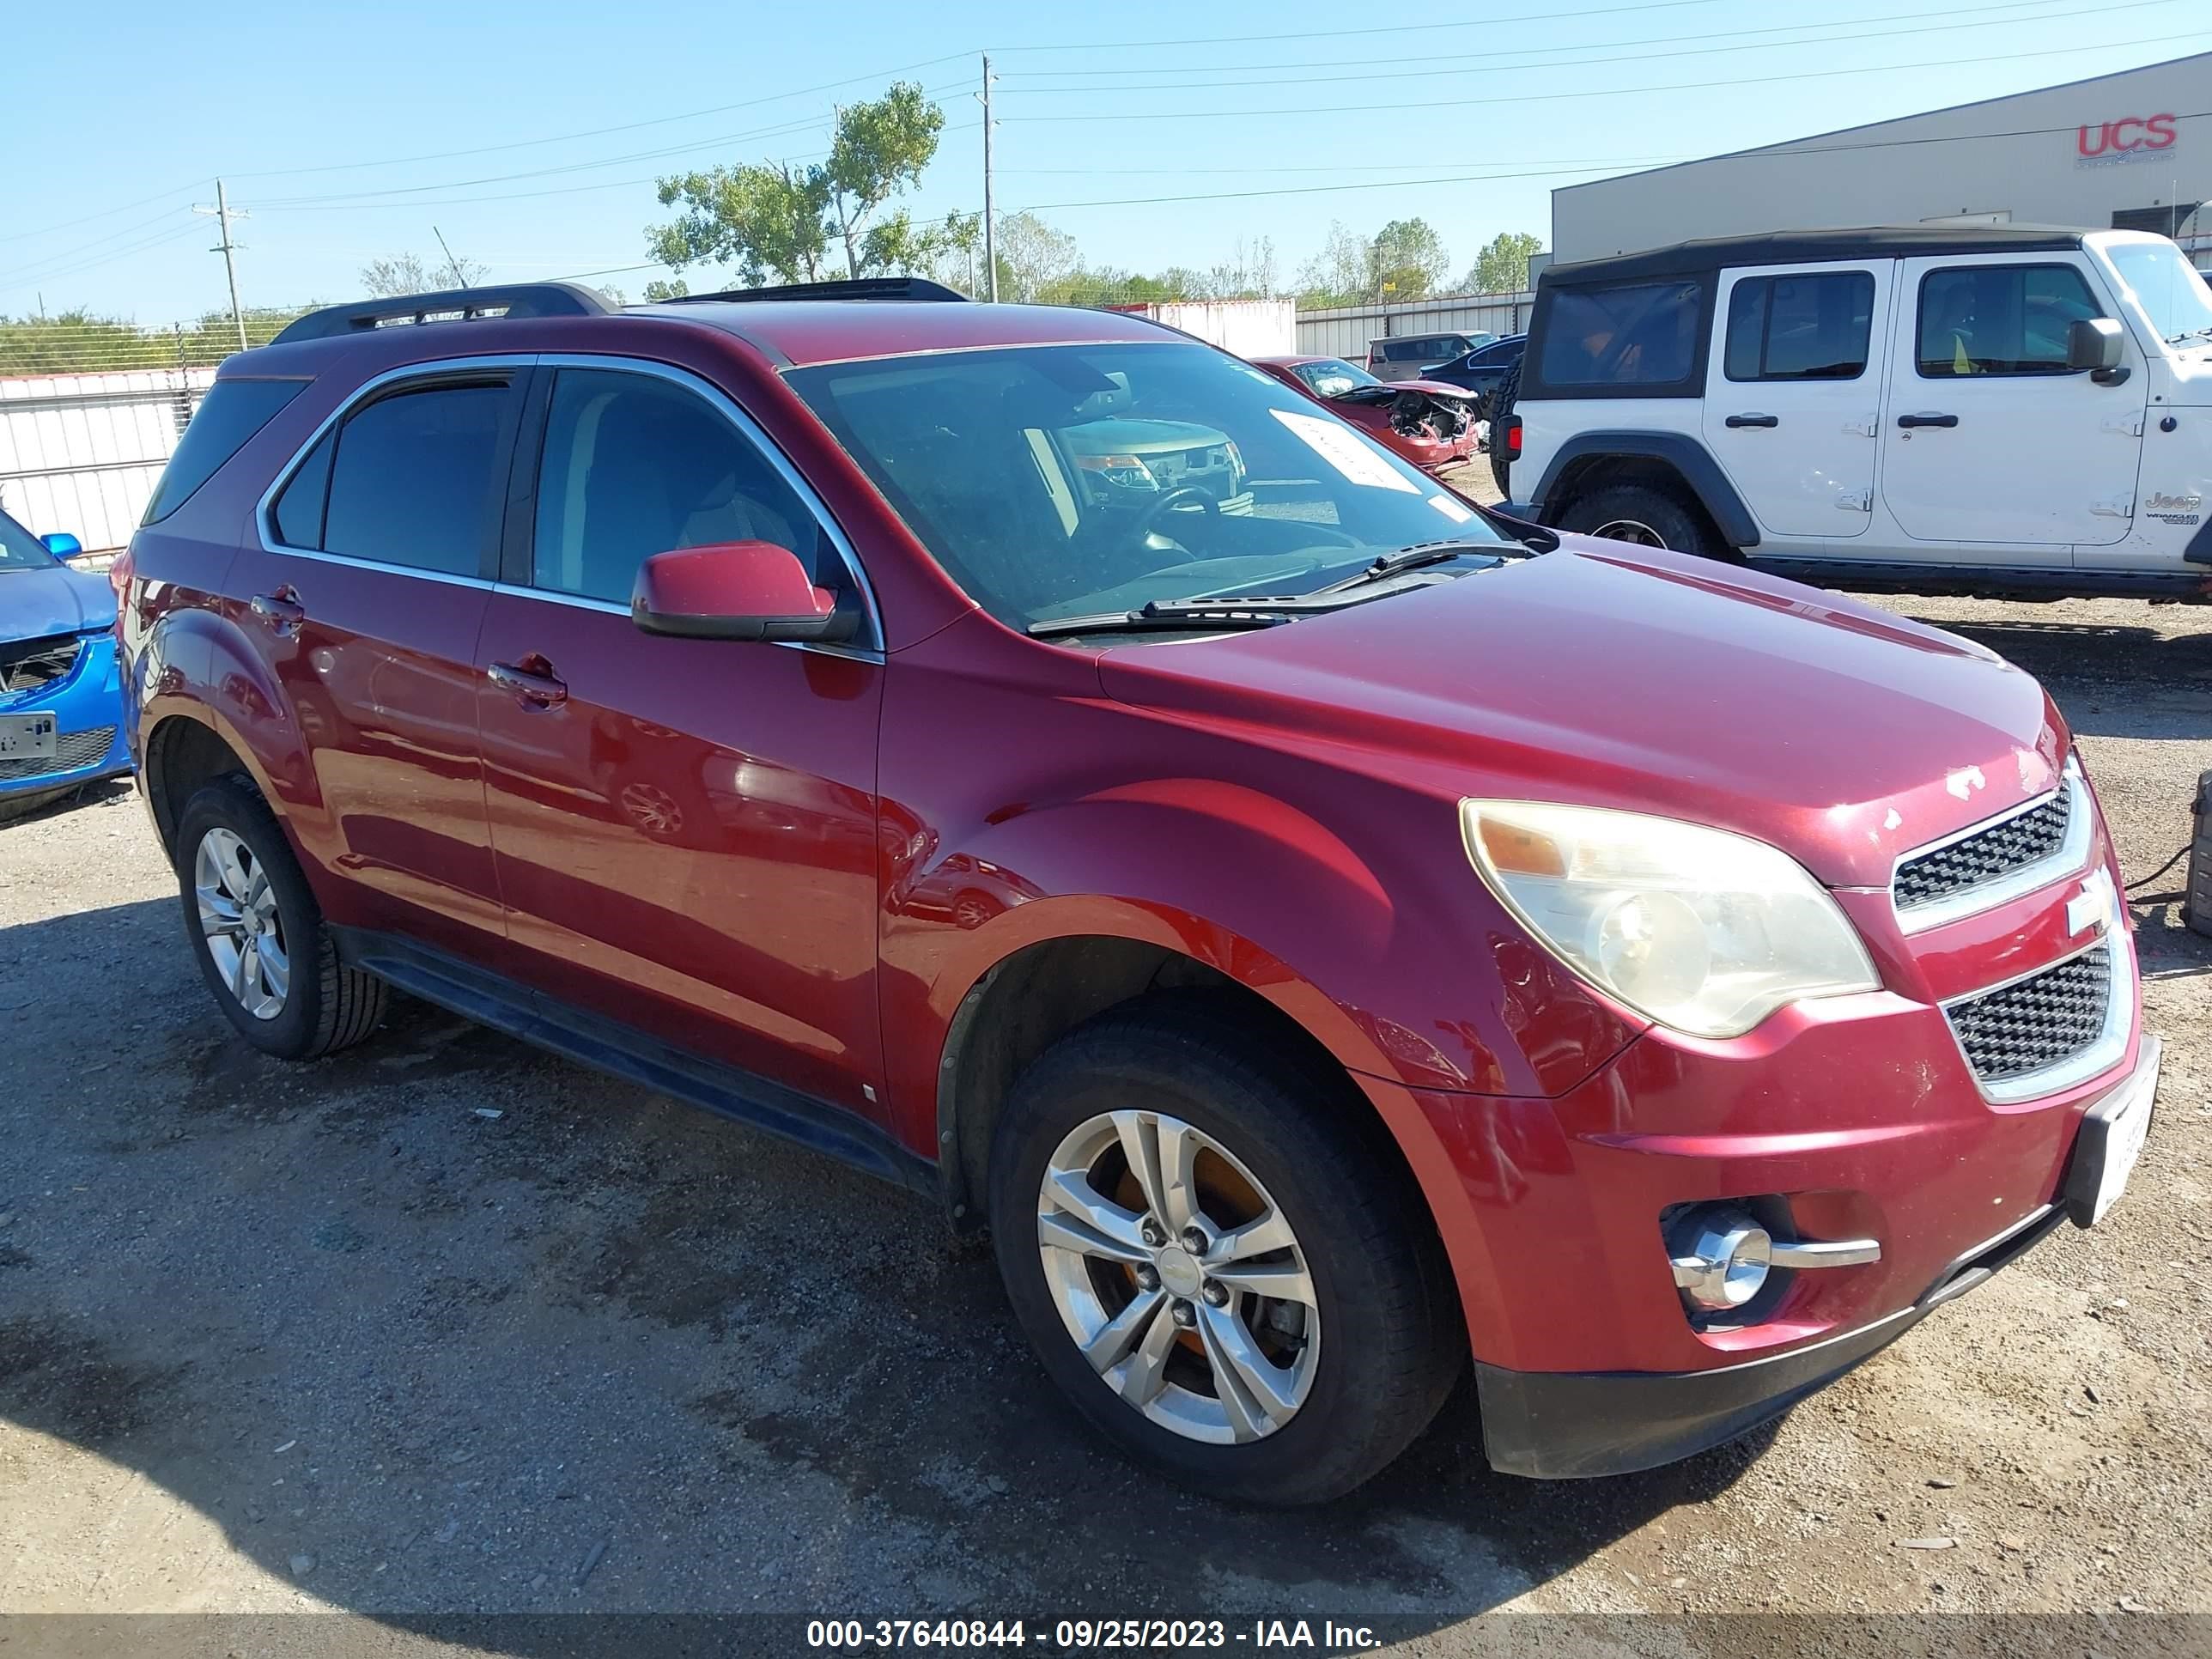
[476,358,883,1115]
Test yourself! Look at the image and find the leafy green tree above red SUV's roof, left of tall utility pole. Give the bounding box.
[646,82,945,288]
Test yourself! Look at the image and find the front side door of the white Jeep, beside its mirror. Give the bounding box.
[1882,254,2148,553]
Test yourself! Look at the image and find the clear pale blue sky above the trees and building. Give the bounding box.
[0,0,2212,325]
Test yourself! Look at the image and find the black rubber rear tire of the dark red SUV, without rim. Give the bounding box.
[173,776,385,1060]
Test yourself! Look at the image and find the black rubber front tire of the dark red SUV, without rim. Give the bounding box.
[991,994,1467,1506]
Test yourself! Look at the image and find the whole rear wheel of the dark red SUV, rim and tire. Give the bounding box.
[175,779,385,1060]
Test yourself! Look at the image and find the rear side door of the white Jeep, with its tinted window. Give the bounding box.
[1704,258,1896,550]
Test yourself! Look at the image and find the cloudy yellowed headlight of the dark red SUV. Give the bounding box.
[1460,801,1882,1037]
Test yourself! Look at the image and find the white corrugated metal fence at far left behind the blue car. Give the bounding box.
[0,368,215,556]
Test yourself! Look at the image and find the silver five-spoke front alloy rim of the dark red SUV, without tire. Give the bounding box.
[1037,1110,1321,1444]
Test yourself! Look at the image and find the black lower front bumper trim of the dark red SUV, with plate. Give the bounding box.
[1475,1037,2159,1480]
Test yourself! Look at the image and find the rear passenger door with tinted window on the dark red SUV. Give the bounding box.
[228,358,529,956]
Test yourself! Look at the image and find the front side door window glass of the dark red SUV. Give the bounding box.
[531,369,834,604]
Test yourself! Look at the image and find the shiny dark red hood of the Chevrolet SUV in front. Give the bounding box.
[1099,538,2063,887]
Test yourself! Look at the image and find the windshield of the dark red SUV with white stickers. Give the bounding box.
[787,341,1504,629]
